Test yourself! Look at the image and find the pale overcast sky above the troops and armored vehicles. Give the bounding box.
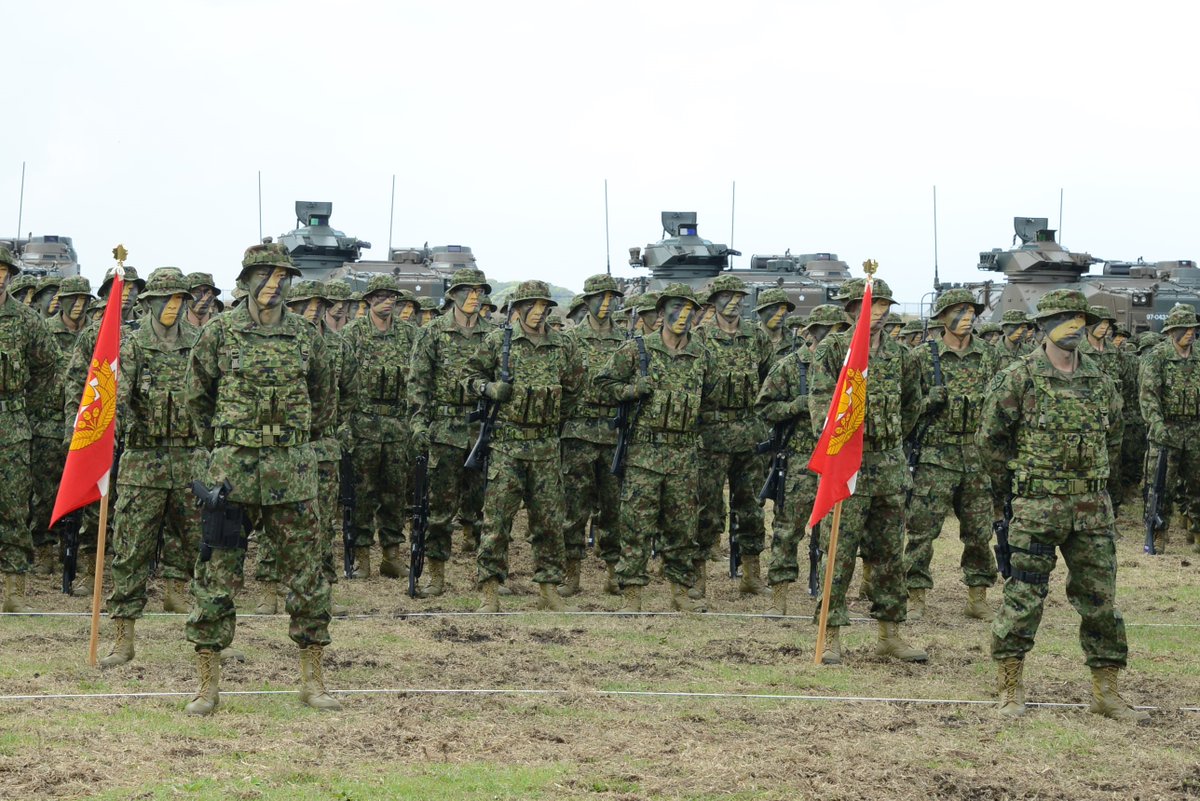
[0,0,1200,301]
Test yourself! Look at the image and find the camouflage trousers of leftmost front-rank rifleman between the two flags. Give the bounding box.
[476,448,564,584]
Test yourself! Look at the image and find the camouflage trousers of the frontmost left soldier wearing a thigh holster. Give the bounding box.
[186,501,330,651]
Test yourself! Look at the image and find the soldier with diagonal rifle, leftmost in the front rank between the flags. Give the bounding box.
[468,281,584,612]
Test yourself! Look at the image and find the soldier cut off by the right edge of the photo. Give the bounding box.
[1138,303,1200,553]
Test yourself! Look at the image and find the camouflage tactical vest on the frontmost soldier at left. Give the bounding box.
[212,323,316,447]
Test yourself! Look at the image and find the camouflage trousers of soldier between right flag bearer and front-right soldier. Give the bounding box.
[905,462,996,590]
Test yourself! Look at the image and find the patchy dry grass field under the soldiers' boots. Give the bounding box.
[0,506,1200,801]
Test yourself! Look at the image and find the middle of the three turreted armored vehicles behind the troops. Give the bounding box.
[624,211,851,314]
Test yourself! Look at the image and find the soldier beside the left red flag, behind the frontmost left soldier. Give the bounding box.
[100,267,205,668]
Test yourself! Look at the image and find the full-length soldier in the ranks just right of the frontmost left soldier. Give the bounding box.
[342,275,420,585]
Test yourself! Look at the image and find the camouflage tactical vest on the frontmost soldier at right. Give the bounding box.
[1012,365,1109,496]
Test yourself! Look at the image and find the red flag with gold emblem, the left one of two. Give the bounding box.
[50,270,125,526]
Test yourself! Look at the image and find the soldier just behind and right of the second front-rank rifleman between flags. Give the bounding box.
[692,276,768,598]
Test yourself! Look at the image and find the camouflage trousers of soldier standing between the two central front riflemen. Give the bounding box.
[563,439,620,565]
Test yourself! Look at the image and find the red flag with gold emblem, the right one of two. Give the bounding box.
[809,276,871,528]
